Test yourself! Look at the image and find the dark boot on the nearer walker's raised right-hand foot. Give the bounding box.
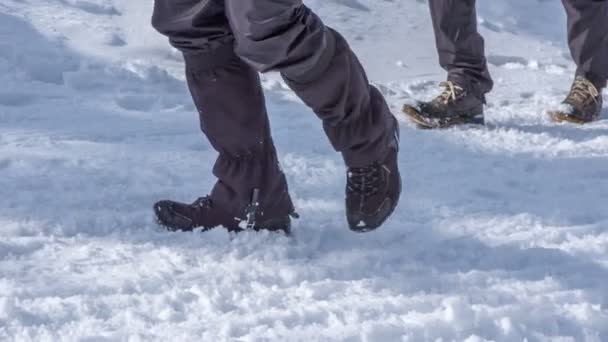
[346,147,401,233]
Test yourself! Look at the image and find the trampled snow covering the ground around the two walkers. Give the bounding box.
[0,0,608,341]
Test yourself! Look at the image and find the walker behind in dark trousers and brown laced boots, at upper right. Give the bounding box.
[404,0,608,128]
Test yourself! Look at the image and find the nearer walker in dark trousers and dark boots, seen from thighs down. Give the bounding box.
[152,0,401,232]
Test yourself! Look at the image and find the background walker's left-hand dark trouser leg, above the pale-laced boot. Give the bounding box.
[429,0,493,95]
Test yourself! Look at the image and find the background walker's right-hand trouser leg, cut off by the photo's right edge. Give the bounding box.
[562,0,608,89]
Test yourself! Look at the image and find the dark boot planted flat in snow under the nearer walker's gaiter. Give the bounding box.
[154,197,297,235]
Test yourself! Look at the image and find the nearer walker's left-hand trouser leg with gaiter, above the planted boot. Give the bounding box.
[153,0,294,231]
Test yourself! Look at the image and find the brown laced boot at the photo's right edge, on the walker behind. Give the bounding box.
[549,76,603,124]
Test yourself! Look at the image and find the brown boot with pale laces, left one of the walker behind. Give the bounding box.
[403,81,485,129]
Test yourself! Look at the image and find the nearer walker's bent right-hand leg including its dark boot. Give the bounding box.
[225,0,400,231]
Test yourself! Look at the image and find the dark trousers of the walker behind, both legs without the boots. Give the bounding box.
[429,0,608,95]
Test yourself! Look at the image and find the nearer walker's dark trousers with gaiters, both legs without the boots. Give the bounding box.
[152,0,396,216]
